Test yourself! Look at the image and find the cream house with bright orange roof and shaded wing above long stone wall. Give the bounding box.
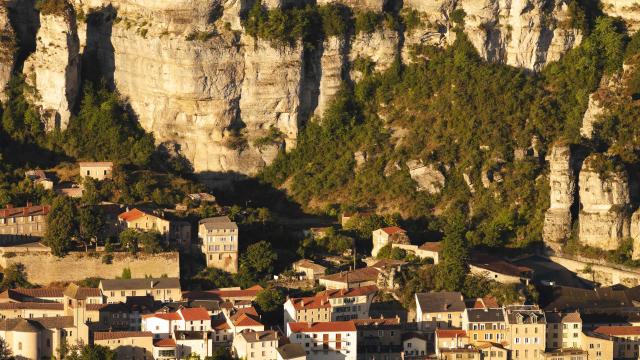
[118,208,191,249]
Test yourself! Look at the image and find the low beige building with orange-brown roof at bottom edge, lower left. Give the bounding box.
[93,331,153,360]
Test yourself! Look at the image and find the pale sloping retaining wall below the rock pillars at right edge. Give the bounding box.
[549,256,640,287]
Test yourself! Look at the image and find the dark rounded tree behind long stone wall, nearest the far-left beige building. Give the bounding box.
[44,196,77,256]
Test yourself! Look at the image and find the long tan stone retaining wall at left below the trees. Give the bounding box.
[0,252,180,285]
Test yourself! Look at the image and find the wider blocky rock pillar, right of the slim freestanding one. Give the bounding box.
[578,156,630,250]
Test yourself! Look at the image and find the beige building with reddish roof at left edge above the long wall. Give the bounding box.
[0,203,51,246]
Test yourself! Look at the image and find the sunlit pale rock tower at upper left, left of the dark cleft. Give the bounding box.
[23,8,80,130]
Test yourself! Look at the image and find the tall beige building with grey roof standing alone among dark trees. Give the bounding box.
[198,216,239,274]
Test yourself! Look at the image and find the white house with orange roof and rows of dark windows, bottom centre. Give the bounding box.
[286,321,358,360]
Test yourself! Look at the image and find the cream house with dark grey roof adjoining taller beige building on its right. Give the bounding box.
[462,309,507,344]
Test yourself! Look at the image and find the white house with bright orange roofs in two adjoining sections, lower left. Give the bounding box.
[142,308,212,339]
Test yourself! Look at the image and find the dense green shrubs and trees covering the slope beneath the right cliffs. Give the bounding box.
[262,17,637,253]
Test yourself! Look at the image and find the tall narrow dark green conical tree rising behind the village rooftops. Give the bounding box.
[436,209,469,291]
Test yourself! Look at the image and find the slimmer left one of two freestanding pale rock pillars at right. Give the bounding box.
[542,145,576,250]
